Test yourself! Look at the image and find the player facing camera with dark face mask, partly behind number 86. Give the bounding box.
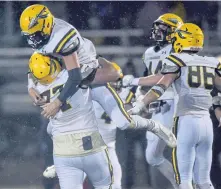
[123,13,183,188]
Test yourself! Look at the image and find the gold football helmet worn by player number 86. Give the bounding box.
[172,23,204,53]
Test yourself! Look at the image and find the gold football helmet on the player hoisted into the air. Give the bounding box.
[20,4,54,49]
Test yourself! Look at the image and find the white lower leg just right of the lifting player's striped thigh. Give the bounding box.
[107,141,122,189]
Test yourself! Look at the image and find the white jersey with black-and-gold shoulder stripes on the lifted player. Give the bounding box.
[35,18,99,78]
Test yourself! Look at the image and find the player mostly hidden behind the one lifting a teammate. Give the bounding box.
[43,80,133,189]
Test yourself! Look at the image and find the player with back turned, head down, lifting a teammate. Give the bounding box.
[29,53,113,189]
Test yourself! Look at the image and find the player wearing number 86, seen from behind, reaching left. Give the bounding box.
[131,23,221,189]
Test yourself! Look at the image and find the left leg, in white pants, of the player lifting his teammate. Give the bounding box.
[54,156,84,189]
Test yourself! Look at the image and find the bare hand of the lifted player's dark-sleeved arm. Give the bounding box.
[41,99,62,119]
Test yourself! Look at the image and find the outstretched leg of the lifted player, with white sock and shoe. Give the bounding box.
[91,84,176,146]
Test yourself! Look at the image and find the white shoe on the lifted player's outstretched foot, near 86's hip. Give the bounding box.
[152,122,177,148]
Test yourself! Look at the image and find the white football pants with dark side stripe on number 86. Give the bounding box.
[172,115,214,189]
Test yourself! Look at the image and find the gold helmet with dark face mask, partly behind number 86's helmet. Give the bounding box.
[152,13,183,43]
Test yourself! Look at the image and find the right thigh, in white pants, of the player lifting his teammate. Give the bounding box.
[82,149,113,189]
